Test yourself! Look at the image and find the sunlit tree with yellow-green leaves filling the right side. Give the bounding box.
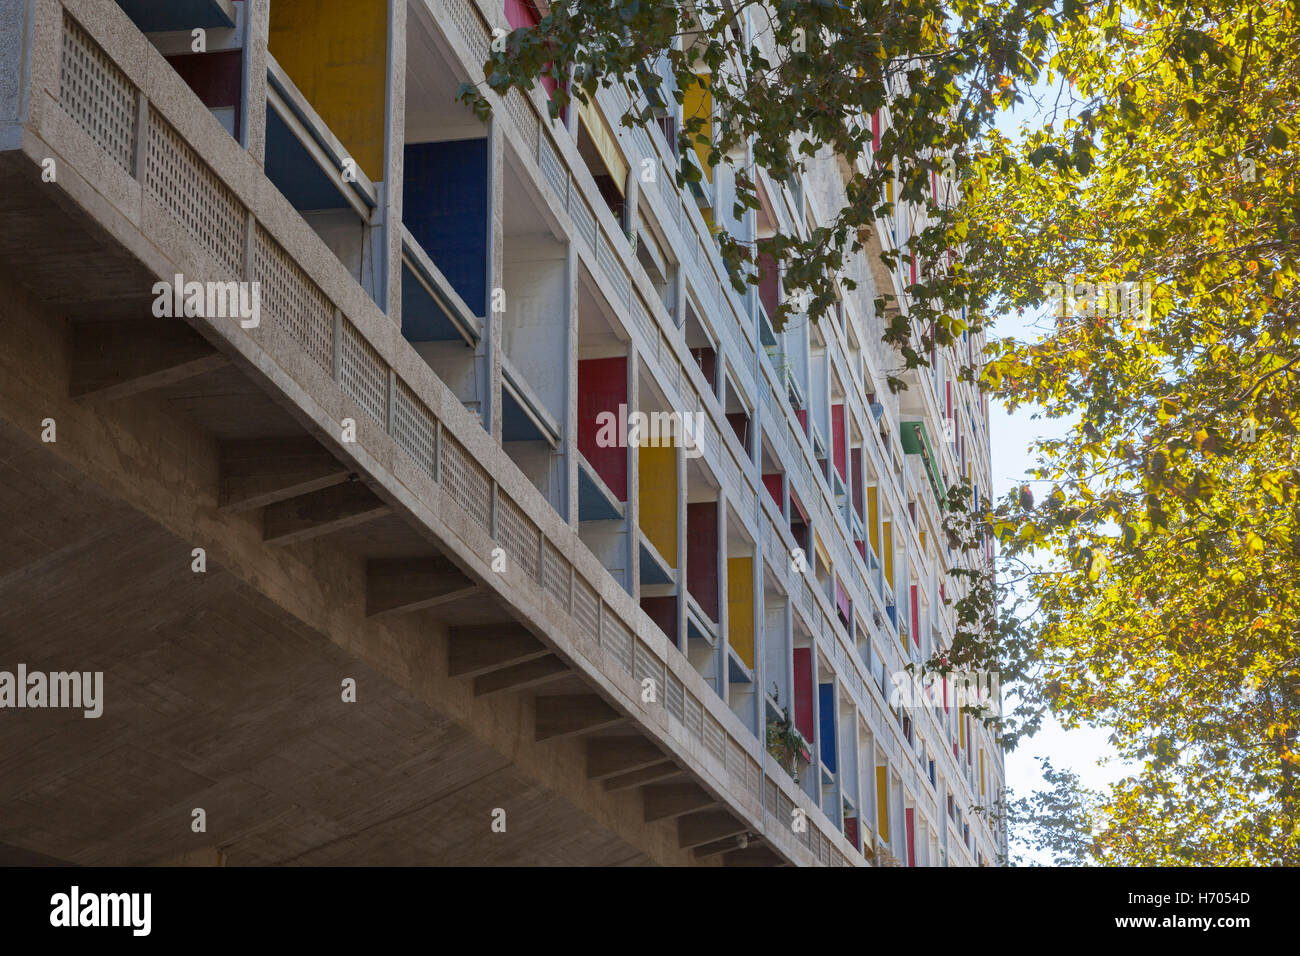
[967,0,1300,865]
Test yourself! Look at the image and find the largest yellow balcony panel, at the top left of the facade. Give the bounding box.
[269,0,389,181]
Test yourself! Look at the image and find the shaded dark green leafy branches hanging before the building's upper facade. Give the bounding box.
[460,0,1056,377]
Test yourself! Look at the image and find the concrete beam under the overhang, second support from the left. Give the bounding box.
[220,437,348,511]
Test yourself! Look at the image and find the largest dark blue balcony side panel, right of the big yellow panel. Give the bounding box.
[402,139,488,316]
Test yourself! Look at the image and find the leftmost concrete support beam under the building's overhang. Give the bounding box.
[68,319,230,401]
